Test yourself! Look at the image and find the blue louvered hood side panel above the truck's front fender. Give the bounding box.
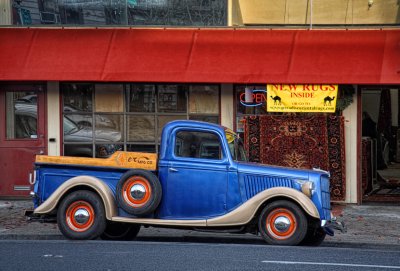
[244,175,294,199]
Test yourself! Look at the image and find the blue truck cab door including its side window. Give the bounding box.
[159,130,229,219]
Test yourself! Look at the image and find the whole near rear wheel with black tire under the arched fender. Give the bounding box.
[57,190,106,240]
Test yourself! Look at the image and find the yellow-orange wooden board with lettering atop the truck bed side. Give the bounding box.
[36,151,157,170]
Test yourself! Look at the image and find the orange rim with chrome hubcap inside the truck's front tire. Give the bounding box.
[265,208,297,240]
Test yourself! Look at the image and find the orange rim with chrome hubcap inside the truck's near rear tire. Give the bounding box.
[65,201,95,232]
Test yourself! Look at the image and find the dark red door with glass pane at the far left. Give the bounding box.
[0,84,47,197]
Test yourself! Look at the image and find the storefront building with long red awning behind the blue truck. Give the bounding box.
[0,0,400,203]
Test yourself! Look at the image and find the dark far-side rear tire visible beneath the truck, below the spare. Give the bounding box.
[100,221,140,241]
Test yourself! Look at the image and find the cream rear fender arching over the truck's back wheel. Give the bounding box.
[33,176,118,220]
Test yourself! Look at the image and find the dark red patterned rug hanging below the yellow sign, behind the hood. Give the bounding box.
[245,114,346,201]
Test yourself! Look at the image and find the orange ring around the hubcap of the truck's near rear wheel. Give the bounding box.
[65,201,95,232]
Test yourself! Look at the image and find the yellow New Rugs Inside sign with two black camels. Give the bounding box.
[267,84,338,113]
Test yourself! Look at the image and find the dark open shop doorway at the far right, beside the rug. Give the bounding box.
[361,86,400,202]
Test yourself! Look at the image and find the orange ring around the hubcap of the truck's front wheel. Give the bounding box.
[265,208,297,240]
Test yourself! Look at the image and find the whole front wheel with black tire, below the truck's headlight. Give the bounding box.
[258,200,307,246]
